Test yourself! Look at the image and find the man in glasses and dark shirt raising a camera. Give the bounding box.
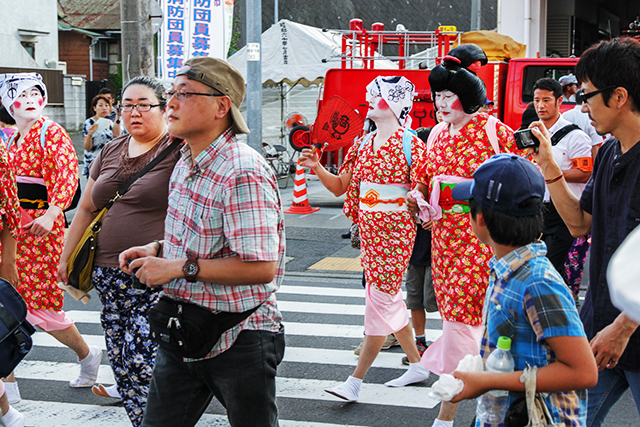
[534,39,640,427]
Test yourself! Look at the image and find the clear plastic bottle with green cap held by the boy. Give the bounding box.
[476,337,515,425]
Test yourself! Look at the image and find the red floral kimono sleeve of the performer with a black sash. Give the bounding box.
[42,123,78,209]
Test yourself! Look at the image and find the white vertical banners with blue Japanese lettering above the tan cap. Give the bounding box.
[162,0,234,79]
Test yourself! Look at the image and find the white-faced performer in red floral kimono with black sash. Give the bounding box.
[0,73,102,399]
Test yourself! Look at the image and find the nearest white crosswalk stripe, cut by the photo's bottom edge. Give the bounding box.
[13,400,372,427]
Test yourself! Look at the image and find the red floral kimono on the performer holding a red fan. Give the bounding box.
[340,128,426,294]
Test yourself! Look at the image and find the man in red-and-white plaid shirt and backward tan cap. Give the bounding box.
[120,57,285,427]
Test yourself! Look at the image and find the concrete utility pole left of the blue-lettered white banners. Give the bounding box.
[120,0,155,84]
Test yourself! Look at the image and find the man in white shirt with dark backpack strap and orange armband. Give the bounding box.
[533,78,593,277]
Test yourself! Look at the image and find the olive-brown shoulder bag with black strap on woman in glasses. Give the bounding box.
[61,139,182,303]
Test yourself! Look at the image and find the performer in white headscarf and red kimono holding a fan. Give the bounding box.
[300,77,429,402]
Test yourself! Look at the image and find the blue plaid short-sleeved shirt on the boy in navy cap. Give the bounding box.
[476,242,587,426]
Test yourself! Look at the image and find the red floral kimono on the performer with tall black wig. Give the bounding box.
[418,114,516,326]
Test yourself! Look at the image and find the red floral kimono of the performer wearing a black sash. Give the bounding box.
[2,117,78,311]
